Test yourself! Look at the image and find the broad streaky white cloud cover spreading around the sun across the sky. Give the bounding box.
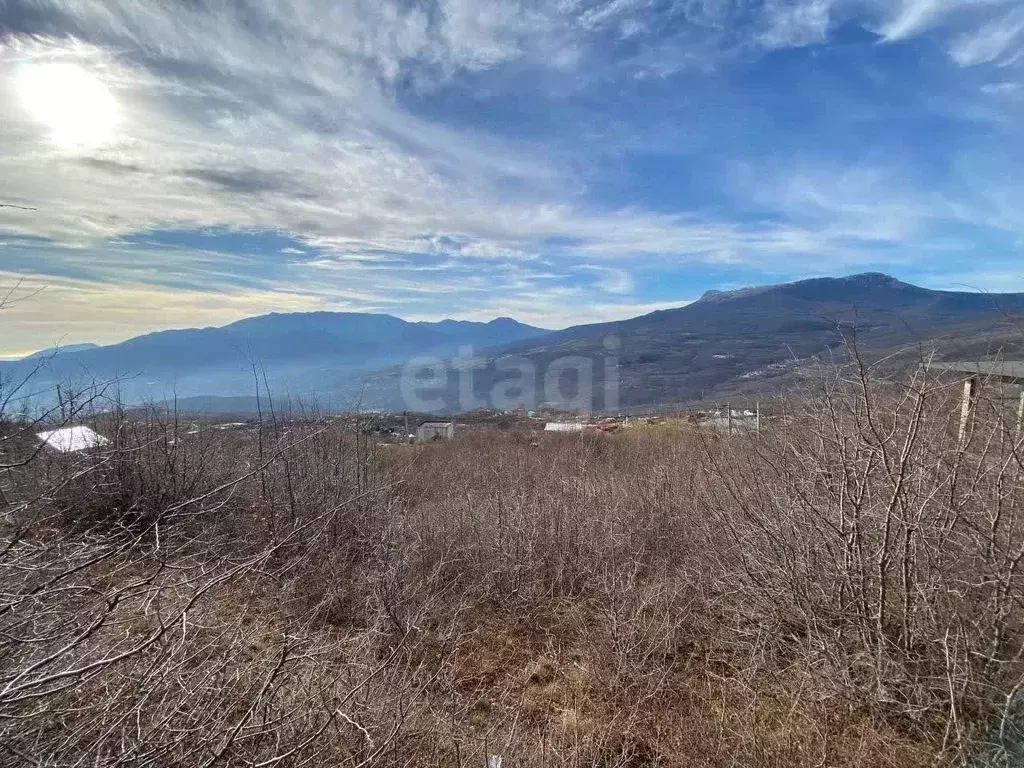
[0,0,1018,354]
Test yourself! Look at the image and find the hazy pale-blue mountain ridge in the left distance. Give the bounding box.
[0,312,547,406]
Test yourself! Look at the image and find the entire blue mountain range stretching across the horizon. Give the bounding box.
[0,273,1024,413]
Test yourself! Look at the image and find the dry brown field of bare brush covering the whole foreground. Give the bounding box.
[0,368,1024,768]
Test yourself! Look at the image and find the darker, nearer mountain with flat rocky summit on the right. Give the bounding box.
[358,272,1024,411]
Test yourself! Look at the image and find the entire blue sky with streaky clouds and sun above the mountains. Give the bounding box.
[0,0,1024,357]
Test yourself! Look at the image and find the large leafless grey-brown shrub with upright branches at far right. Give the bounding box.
[702,358,1024,754]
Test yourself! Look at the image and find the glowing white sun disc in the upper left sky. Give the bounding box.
[17,61,118,147]
